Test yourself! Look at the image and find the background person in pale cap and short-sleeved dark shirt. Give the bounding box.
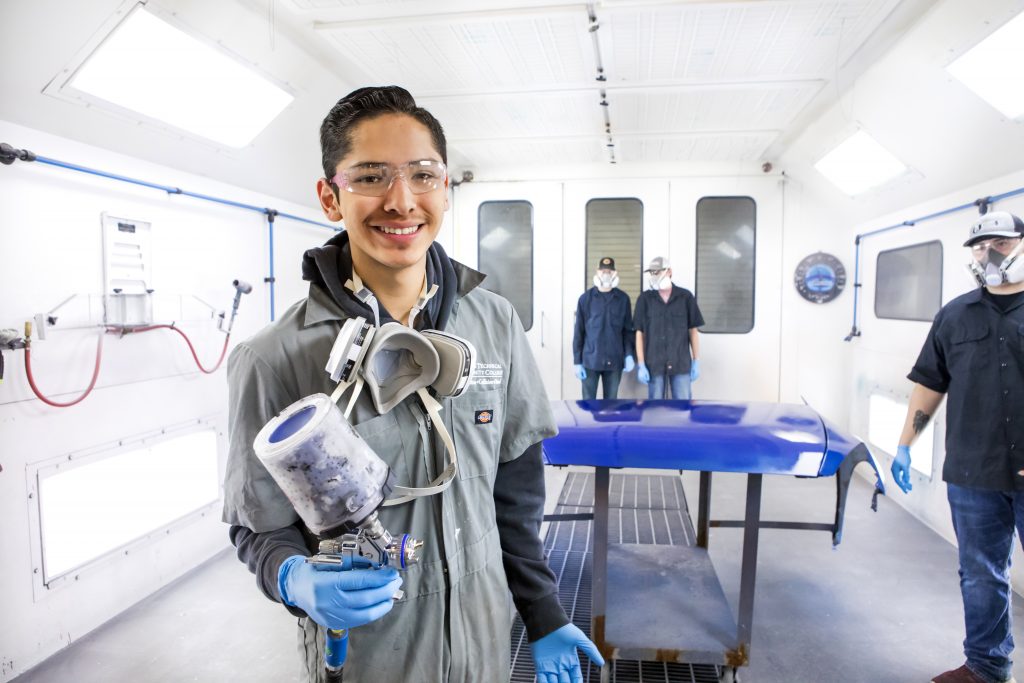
[633,256,705,399]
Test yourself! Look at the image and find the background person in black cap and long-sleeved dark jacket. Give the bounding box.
[572,256,635,399]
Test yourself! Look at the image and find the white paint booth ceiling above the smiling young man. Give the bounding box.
[0,0,1007,211]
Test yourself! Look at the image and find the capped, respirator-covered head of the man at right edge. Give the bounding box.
[964,211,1024,287]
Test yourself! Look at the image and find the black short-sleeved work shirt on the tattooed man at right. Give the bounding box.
[907,289,1024,492]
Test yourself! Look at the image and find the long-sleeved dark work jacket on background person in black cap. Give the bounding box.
[572,287,635,372]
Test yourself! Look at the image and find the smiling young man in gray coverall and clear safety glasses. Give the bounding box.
[224,86,603,683]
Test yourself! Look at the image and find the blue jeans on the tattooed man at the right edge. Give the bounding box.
[946,483,1024,683]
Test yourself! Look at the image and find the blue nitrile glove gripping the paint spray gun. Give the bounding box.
[278,555,401,629]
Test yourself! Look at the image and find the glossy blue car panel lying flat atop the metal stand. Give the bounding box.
[544,400,831,476]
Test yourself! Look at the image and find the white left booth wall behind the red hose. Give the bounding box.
[0,122,331,681]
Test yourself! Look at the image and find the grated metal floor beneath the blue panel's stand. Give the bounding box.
[509,472,719,683]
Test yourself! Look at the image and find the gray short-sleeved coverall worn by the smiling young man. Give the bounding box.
[224,265,556,683]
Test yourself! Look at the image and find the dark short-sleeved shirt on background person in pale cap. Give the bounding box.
[633,285,703,375]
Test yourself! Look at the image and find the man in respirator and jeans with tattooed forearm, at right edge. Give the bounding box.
[892,211,1024,683]
